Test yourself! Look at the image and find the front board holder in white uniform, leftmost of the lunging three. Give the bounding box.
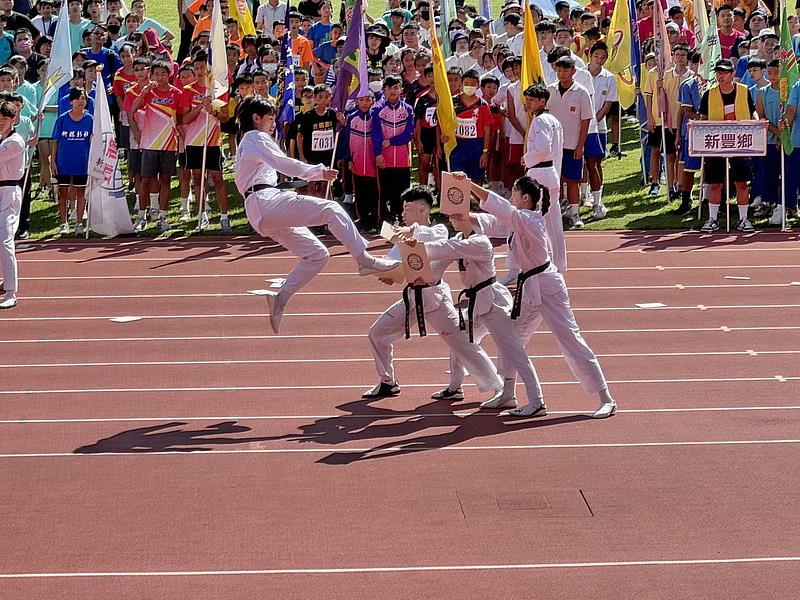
[362,186,503,400]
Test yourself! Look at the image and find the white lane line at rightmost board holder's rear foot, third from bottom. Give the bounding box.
[0,405,800,425]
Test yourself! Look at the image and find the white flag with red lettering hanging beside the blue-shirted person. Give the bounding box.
[86,71,133,237]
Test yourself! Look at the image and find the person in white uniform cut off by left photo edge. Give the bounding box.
[0,101,25,309]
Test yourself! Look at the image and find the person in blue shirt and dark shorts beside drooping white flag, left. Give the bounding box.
[53,87,94,236]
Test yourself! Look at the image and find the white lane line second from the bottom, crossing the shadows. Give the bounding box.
[0,438,800,459]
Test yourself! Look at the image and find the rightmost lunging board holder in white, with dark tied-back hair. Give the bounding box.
[472,171,617,419]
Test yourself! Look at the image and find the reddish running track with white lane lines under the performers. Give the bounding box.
[0,233,800,600]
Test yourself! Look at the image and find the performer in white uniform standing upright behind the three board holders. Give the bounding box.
[522,85,567,275]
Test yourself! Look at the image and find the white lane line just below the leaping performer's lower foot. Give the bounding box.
[6,325,800,344]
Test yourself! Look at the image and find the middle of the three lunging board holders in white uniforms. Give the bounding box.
[425,210,547,416]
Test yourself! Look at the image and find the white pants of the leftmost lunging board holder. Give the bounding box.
[369,300,503,392]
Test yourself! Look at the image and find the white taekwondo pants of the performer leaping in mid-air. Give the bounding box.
[244,190,367,294]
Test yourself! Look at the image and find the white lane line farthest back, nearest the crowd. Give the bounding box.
[18,244,800,263]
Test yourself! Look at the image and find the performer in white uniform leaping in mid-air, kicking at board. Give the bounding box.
[236,96,398,333]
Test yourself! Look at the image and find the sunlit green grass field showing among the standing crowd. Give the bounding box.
[26,0,763,238]
